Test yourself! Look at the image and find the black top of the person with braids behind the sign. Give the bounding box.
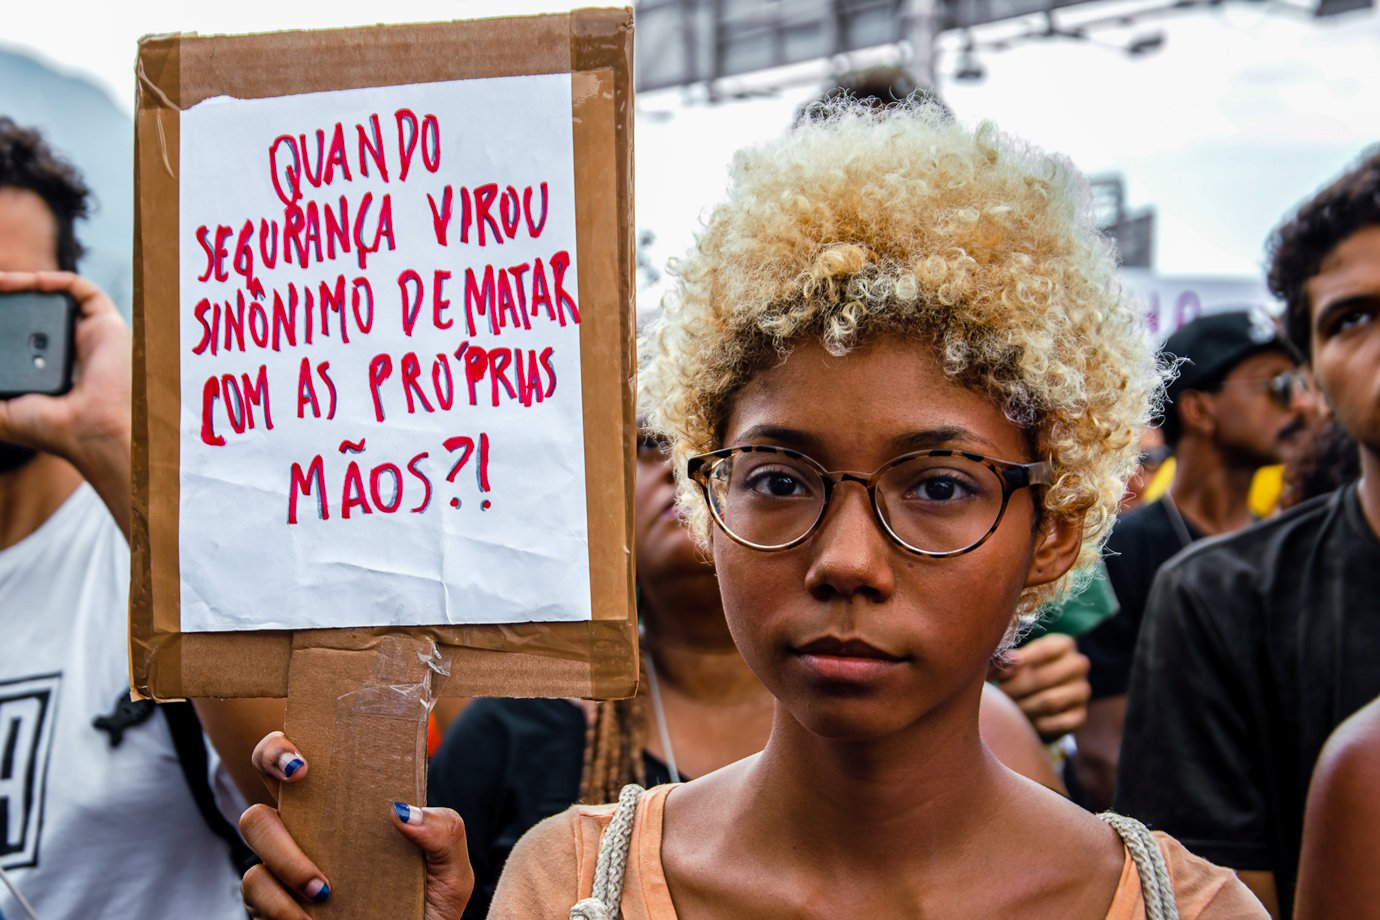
[426,699,671,920]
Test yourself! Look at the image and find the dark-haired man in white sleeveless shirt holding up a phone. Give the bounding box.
[0,119,244,920]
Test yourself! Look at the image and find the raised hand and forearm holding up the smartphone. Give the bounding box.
[0,272,131,539]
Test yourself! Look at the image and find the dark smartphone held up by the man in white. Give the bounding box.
[0,291,77,399]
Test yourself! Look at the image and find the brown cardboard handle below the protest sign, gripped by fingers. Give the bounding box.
[279,636,432,920]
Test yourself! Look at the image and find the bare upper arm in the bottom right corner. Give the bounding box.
[1291,699,1380,920]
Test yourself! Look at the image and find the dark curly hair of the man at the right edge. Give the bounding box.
[1267,148,1380,357]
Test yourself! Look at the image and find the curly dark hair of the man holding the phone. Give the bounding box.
[0,117,91,272]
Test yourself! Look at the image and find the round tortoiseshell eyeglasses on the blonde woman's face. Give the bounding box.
[686,446,1054,556]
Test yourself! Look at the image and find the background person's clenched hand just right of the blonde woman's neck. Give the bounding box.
[991,633,1092,741]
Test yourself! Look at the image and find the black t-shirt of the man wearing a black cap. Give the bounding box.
[1078,498,1202,699]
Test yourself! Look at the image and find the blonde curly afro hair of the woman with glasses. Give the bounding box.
[640,101,1161,614]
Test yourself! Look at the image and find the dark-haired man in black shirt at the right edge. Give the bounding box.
[1116,147,1380,917]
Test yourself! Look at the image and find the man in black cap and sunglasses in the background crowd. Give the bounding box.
[1075,310,1303,810]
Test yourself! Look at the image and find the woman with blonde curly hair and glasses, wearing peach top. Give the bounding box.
[237,102,1264,920]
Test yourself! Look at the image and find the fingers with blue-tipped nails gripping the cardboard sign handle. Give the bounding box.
[240,731,475,920]
